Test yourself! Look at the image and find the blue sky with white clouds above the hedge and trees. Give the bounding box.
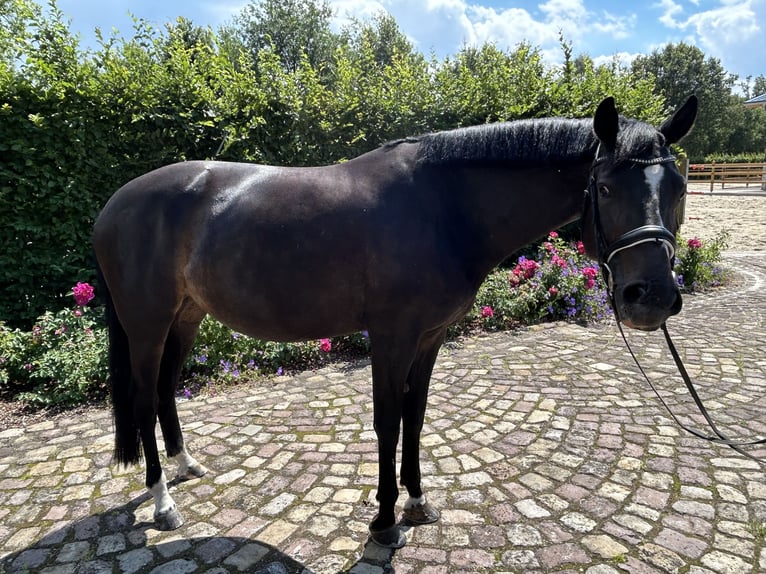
[58,0,766,83]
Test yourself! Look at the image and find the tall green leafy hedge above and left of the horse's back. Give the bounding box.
[0,0,663,327]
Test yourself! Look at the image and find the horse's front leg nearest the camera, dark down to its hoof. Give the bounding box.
[370,330,416,548]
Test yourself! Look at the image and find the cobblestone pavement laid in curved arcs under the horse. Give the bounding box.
[0,252,766,574]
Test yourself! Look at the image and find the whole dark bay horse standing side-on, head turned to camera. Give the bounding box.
[93,96,697,547]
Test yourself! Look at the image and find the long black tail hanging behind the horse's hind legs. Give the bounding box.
[96,264,141,466]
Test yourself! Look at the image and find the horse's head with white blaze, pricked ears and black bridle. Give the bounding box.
[583,96,697,330]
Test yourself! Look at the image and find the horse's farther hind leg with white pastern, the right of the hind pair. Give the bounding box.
[157,300,207,480]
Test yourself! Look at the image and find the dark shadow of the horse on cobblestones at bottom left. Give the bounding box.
[0,493,407,574]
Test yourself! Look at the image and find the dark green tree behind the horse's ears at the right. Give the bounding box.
[632,43,736,160]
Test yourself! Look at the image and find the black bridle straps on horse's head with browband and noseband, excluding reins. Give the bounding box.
[585,153,676,296]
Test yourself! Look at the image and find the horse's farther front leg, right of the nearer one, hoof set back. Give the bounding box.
[401,330,446,524]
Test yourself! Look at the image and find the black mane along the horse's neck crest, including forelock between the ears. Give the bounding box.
[408,117,664,167]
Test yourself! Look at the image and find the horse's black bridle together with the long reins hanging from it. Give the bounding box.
[585,153,766,464]
